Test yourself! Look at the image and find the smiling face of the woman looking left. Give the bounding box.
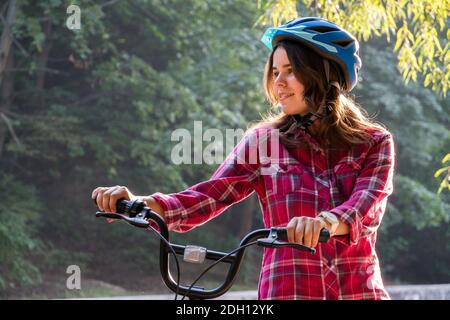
[272,47,308,115]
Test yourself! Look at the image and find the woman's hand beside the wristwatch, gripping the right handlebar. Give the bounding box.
[287,217,330,248]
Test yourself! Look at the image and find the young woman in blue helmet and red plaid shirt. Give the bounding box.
[92,17,395,299]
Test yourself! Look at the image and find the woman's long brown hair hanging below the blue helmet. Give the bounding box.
[249,40,386,148]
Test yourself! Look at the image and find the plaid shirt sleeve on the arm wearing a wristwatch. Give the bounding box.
[330,133,395,245]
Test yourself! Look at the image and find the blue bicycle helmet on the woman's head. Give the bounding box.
[261,17,361,92]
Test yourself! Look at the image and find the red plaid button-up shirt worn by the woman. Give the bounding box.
[152,128,395,299]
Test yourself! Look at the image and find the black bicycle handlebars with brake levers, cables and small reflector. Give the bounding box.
[94,199,330,300]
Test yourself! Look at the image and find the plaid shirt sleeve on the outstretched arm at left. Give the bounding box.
[151,131,260,232]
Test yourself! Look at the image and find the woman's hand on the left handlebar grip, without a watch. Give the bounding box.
[92,186,137,212]
